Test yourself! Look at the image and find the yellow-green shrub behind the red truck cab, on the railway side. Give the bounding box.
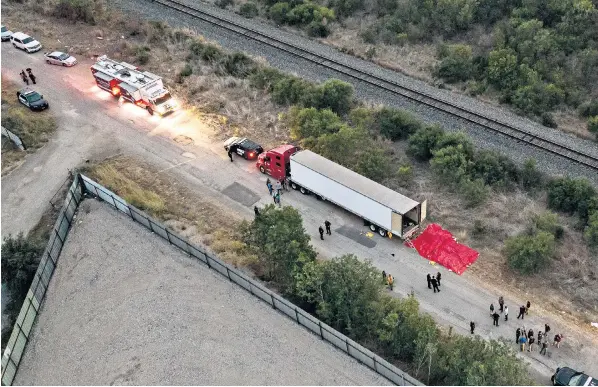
[288,106,342,140]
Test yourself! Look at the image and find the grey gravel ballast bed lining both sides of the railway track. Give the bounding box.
[111,0,598,185]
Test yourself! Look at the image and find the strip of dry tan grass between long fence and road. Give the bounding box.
[85,156,255,266]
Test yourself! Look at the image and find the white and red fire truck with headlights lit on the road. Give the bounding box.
[91,55,178,115]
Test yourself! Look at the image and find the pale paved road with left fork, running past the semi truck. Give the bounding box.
[2,49,598,383]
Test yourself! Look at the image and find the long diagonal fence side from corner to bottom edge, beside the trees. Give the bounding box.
[81,175,423,386]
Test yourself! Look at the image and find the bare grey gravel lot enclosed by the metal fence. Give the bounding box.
[14,199,389,385]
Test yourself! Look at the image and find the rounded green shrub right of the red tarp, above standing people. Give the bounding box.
[505,231,555,274]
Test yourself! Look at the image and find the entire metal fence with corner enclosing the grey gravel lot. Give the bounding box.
[1,175,423,386]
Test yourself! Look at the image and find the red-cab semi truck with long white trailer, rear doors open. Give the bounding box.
[256,145,427,239]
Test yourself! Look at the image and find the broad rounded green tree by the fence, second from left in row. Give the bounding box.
[296,254,382,338]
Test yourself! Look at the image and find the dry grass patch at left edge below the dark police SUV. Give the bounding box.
[2,77,56,175]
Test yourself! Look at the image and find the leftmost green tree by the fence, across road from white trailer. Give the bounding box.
[241,204,316,293]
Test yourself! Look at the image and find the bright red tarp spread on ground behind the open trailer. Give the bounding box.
[406,223,480,274]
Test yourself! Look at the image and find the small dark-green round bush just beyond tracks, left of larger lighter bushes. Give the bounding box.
[434,44,473,83]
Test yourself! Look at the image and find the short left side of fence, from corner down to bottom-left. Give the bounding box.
[1,179,83,386]
